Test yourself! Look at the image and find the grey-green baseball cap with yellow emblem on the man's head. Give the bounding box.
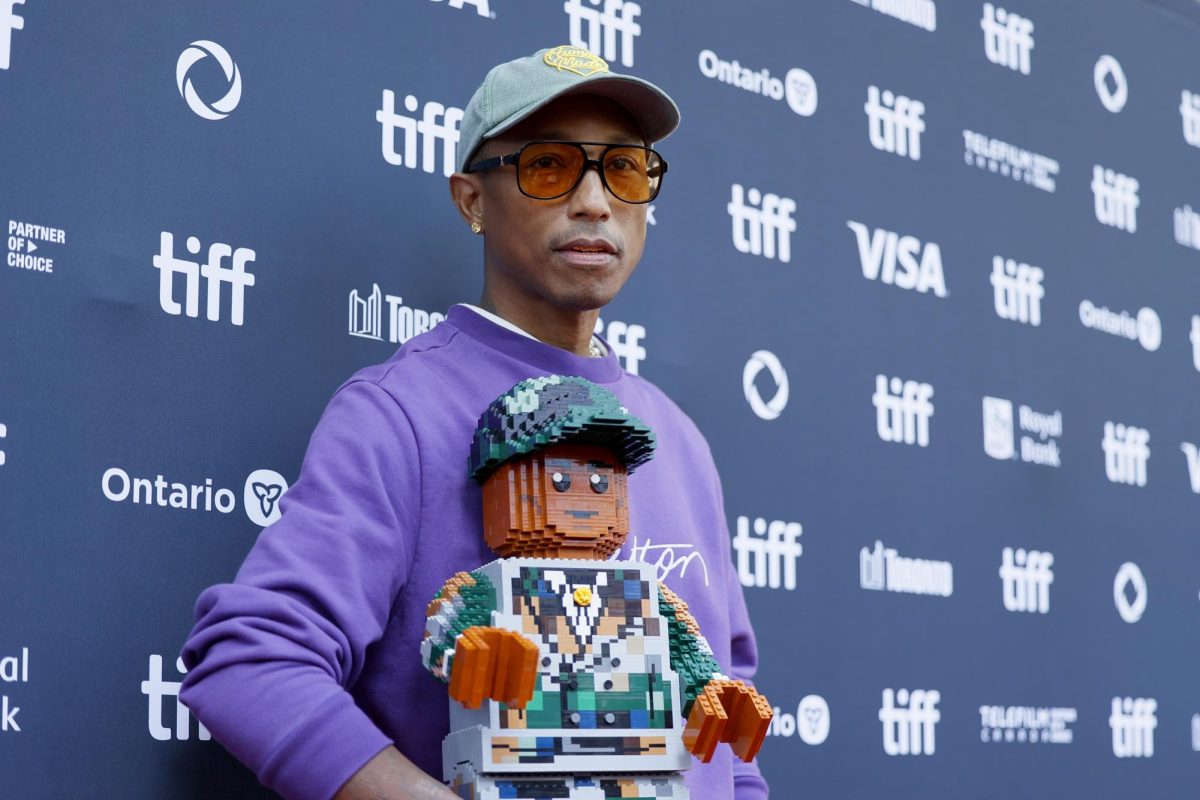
[458,44,679,169]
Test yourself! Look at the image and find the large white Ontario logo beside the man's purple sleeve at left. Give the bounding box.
[100,467,288,528]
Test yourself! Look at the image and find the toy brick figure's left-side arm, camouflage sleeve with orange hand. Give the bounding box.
[421,572,538,709]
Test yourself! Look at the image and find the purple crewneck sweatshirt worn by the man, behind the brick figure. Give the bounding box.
[180,306,767,800]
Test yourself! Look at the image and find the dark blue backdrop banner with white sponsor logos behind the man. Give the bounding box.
[0,0,1200,799]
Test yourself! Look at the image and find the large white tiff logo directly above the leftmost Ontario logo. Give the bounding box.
[154,230,254,325]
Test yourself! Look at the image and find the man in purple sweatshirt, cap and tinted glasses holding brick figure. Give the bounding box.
[181,47,767,800]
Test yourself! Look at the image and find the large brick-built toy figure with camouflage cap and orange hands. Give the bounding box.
[421,375,772,800]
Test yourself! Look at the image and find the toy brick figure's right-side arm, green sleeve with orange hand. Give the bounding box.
[659,583,773,763]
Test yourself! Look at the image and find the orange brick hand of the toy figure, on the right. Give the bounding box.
[683,680,774,764]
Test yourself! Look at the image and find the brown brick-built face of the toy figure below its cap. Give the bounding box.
[484,445,629,559]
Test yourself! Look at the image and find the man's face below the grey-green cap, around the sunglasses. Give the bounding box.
[463,95,646,313]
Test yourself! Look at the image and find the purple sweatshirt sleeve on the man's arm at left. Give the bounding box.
[180,380,421,800]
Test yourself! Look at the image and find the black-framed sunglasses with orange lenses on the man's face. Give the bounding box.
[467,142,667,203]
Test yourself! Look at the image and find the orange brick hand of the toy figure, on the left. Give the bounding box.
[450,625,538,709]
